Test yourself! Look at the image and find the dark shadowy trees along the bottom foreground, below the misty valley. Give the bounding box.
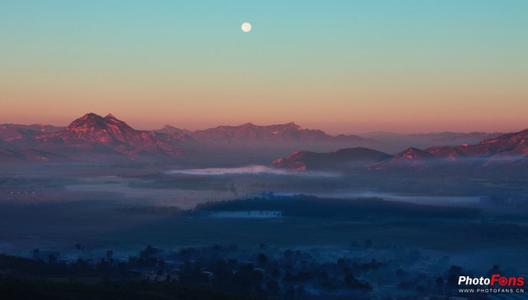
[0,246,508,300]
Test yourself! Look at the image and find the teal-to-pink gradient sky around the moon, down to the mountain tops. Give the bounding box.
[0,0,528,134]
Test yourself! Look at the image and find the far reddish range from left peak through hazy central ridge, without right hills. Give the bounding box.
[0,113,374,161]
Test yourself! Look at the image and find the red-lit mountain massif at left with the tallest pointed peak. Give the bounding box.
[0,113,181,161]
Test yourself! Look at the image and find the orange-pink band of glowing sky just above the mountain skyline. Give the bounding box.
[0,81,528,134]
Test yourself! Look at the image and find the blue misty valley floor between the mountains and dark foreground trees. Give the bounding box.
[0,166,528,290]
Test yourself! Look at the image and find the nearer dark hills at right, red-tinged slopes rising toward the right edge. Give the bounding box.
[273,129,528,171]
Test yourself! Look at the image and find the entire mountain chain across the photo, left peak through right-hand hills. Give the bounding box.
[0,113,528,170]
